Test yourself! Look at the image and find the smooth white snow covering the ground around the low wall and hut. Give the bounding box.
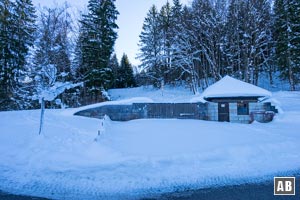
[0,88,300,199]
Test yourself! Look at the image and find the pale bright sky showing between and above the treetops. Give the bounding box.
[32,0,190,65]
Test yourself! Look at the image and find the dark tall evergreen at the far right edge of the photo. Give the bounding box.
[274,0,300,91]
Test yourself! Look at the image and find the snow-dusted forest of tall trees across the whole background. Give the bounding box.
[0,0,300,110]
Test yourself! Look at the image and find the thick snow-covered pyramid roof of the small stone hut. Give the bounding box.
[202,76,272,99]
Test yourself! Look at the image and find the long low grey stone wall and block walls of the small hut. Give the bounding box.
[75,102,277,124]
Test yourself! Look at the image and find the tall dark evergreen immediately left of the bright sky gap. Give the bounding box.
[77,0,119,101]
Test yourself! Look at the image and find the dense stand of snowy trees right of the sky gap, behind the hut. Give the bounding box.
[139,0,300,90]
